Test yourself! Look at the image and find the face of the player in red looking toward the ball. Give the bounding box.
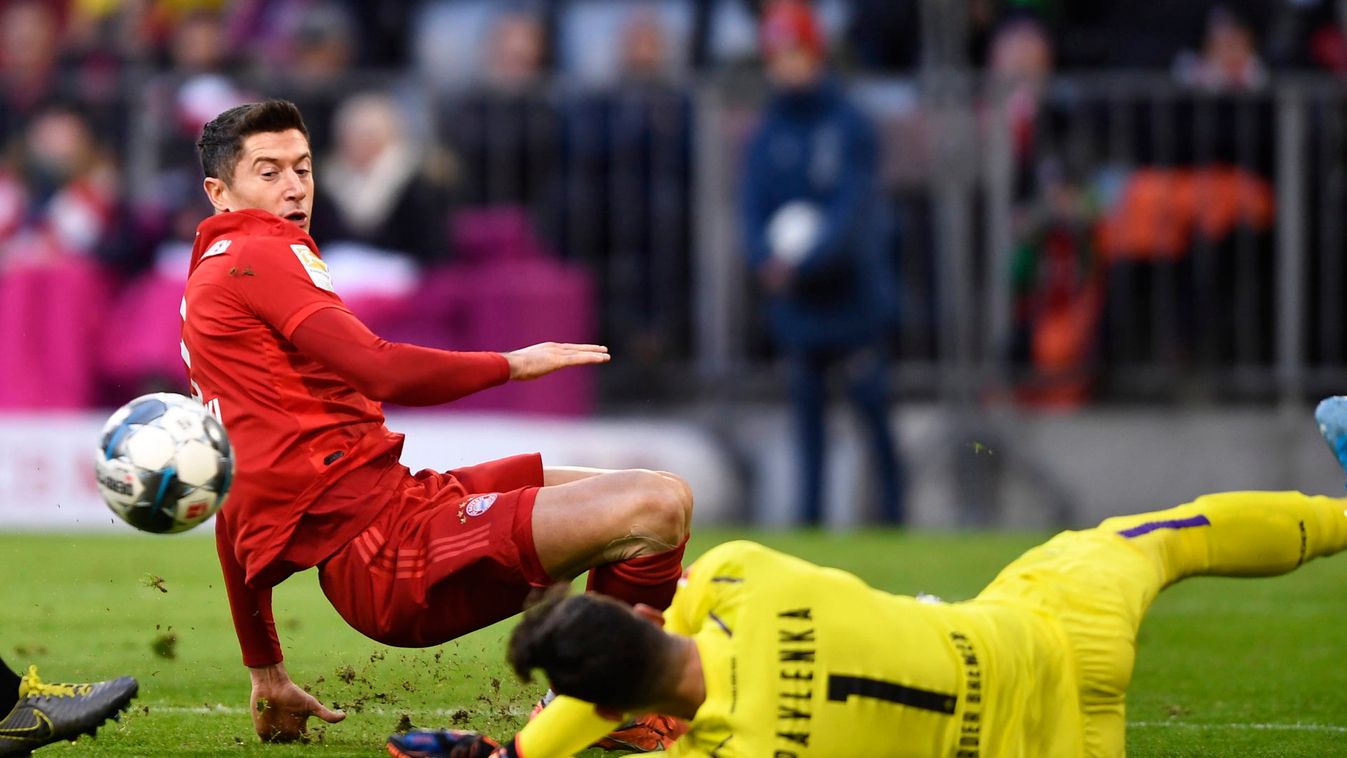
[206,129,314,232]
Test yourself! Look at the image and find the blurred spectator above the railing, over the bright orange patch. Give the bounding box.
[1175,5,1268,92]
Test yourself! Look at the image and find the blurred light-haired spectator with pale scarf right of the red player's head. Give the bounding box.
[311,94,449,265]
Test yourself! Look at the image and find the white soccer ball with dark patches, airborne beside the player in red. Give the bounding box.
[94,392,234,535]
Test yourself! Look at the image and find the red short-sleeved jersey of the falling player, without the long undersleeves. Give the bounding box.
[182,210,508,586]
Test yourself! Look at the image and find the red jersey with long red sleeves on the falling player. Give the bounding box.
[182,210,509,666]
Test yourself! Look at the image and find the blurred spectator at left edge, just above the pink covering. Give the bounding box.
[0,106,119,263]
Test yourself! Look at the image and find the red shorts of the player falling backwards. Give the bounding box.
[318,454,551,648]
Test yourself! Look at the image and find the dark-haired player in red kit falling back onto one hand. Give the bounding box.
[182,101,692,739]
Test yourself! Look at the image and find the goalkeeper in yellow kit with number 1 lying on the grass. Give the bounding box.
[388,404,1347,758]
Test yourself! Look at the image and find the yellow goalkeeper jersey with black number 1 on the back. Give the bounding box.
[520,541,1083,758]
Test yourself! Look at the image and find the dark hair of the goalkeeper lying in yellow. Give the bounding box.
[508,584,680,712]
